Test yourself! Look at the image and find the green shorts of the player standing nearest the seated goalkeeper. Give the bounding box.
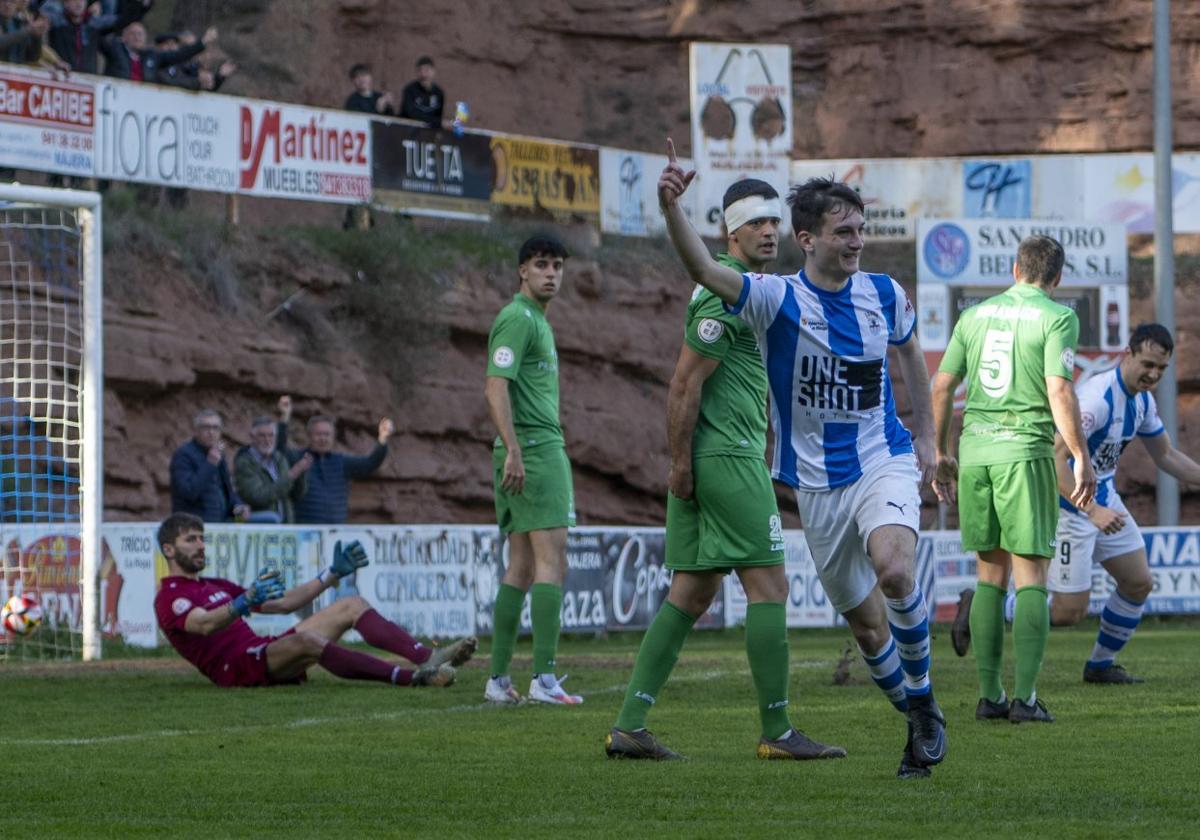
[492,445,575,534]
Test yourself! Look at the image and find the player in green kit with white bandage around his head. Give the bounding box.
[605,179,846,760]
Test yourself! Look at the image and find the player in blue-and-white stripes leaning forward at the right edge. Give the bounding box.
[1048,324,1200,684]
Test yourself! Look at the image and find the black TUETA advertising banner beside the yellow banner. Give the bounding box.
[371,120,492,221]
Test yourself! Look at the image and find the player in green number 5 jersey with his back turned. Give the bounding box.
[934,236,1096,724]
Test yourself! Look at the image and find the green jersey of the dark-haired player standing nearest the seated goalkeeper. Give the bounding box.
[487,292,563,449]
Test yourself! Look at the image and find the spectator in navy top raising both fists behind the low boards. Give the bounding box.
[278,396,396,524]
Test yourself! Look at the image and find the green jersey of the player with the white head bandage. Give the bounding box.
[684,253,767,460]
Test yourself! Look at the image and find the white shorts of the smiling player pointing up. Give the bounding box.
[796,455,920,613]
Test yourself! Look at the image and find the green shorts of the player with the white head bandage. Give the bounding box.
[666,455,784,572]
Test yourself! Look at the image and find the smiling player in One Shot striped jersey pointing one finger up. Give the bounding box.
[659,140,946,778]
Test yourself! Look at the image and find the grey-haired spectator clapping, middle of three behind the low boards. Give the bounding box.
[233,416,312,523]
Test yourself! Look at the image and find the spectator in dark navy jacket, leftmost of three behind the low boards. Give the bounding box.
[170,408,249,522]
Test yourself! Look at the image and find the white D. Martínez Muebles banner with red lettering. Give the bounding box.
[238,100,371,204]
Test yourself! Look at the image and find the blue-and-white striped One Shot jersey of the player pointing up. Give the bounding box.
[727,271,916,491]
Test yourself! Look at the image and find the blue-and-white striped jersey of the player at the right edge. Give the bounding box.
[1058,365,1166,511]
